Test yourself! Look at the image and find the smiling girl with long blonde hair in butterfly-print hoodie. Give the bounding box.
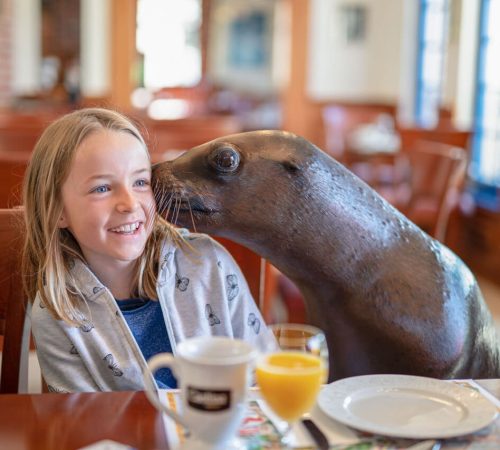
[23,108,267,392]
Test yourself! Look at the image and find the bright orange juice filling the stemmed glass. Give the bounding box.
[256,351,324,422]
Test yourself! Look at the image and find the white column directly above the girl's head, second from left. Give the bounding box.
[80,0,111,97]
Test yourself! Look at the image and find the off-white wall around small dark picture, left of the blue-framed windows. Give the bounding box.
[307,0,407,103]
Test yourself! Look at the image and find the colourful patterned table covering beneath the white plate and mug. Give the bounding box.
[160,380,500,450]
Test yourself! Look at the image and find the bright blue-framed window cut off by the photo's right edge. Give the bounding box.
[471,0,500,187]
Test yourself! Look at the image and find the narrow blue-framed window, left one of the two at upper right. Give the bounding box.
[415,0,449,128]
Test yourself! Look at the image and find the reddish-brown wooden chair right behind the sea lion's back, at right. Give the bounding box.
[395,141,468,242]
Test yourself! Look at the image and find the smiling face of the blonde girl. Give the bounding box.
[59,130,155,274]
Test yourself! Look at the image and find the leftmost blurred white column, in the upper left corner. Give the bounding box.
[12,0,42,95]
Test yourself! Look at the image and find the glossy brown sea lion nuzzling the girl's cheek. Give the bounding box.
[152,131,500,380]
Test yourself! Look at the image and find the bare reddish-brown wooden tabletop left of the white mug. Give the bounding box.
[0,391,168,450]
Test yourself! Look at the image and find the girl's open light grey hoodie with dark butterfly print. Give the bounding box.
[31,231,270,392]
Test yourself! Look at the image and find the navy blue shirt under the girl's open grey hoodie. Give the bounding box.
[116,298,177,389]
